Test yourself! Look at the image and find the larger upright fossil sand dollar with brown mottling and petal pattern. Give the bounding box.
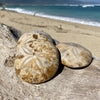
[15,33,59,84]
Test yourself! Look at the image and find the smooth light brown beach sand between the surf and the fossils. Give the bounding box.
[0,10,100,57]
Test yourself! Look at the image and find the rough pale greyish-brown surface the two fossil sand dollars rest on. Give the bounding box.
[0,23,100,100]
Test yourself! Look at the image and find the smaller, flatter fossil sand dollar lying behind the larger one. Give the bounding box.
[56,43,92,68]
